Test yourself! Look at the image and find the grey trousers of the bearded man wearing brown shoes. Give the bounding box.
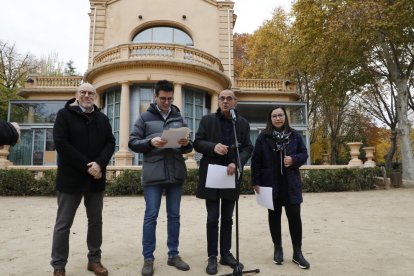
[50,192,103,269]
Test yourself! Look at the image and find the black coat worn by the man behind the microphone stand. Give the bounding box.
[194,111,253,200]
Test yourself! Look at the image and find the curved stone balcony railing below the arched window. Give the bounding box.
[93,43,224,72]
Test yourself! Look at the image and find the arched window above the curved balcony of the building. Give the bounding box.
[132,26,194,46]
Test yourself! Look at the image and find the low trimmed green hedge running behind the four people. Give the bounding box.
[0,168,380,196]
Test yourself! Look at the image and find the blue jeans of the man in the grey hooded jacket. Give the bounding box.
[142,183,182,260]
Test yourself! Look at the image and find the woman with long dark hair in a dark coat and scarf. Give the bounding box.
[251,107,310,269]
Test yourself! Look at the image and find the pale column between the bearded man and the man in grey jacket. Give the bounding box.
[114,82,134,166]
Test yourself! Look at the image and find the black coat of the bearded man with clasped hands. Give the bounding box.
[53,99,115,194]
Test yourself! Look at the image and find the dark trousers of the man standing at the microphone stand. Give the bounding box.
[206,199,235,257]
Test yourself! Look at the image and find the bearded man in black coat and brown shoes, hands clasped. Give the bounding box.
[51,83,115,276]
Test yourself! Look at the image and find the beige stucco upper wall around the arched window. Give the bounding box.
[89,0,234,80]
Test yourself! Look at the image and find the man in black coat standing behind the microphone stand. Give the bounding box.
[194,90,253,275]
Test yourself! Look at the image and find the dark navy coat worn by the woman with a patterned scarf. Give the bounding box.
[251,130,308,204]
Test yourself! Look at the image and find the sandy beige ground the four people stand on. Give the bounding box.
[0,188,414,276]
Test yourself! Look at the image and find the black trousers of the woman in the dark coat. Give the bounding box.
[268,204,302,249]
